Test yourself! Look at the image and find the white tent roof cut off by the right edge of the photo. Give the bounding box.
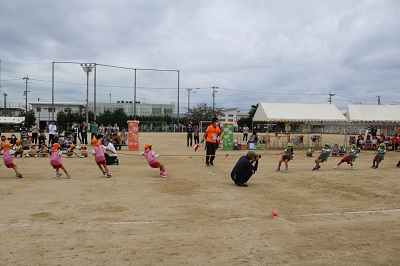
[346,105,400,123]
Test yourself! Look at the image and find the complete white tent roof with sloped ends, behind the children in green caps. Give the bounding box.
[253,103,346,122]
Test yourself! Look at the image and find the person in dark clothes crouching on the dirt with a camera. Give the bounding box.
[231,151,261,187]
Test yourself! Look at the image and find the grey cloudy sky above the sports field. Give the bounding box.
[0,0,400,113]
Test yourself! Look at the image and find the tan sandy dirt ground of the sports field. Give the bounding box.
[0,133,400,265]
